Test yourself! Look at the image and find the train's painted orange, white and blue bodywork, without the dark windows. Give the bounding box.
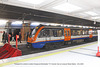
[27,26,97,48]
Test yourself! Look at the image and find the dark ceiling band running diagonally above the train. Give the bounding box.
[0,0,100,27]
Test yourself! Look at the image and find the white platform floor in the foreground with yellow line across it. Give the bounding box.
[0,42,100,67]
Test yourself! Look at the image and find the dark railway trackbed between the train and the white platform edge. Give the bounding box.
[18,41,96,55]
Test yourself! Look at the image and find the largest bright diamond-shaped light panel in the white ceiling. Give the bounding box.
[53,3,81,12]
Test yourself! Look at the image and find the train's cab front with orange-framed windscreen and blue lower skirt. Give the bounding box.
[26,25,44,48]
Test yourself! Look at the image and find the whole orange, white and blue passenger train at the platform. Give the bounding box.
[26,25,98,49]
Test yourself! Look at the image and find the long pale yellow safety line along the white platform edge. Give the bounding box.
[0,42,97,67]
